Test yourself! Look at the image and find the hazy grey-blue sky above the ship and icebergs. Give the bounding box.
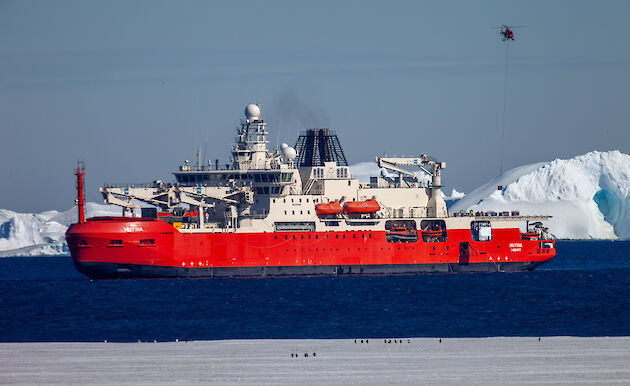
[0,0,630,211]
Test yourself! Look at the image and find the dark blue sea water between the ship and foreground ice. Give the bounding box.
[0,241,630,342]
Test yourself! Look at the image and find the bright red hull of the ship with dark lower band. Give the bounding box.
[66,217,555,278]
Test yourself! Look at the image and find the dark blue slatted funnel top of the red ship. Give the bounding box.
[295,129,348,166]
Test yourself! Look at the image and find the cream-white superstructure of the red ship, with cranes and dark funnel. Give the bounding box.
[101,104,462,232]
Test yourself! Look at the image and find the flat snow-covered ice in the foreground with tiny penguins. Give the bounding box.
[0,337,630,385]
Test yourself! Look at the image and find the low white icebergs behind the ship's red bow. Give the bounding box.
[0,202,121,257]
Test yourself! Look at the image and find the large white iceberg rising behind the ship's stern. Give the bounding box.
[450,151,630,239]
